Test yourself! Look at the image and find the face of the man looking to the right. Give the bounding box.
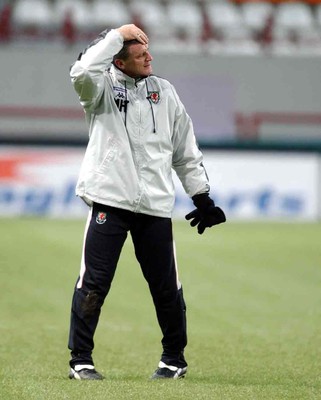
[121,43,153,78]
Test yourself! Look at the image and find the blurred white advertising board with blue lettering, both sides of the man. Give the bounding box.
[0,147,320,221]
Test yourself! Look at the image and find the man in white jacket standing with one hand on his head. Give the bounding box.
[69,24,225,379]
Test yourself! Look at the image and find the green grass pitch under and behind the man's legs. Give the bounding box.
[0,218,321,400]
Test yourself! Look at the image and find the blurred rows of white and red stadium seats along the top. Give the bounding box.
[0,0,321,54]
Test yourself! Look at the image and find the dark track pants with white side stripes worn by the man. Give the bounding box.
[68,203,187,367]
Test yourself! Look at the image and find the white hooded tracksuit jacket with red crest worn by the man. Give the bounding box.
[70,30,209,217]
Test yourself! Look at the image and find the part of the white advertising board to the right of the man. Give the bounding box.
[172,151,320,221]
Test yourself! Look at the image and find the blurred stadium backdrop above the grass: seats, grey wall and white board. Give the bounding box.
[0,0,321,221]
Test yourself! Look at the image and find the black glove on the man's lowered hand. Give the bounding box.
[185,193,226,235]
